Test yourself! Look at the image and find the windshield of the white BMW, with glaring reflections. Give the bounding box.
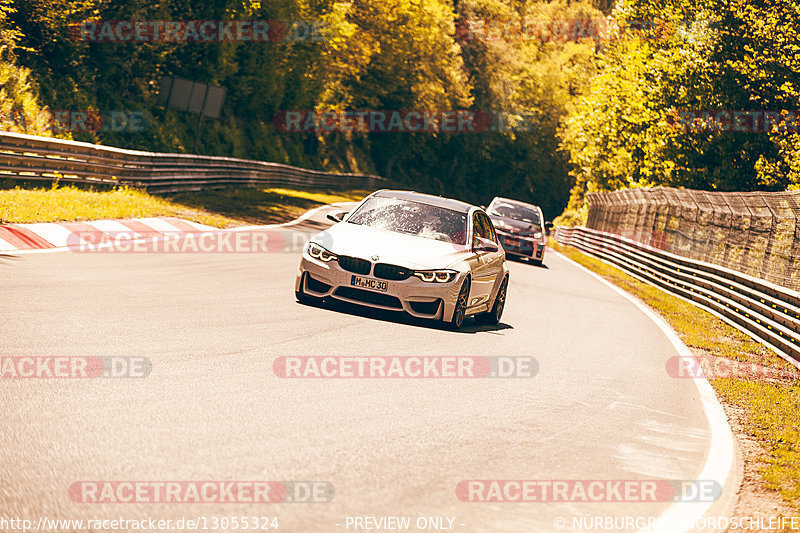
[347,196,467,244]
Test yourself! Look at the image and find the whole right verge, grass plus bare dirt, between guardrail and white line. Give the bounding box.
[549,238,800,516]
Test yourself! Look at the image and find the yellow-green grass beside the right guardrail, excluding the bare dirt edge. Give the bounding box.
[549,239,800,510]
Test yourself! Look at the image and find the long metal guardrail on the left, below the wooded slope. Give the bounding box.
[0,132,392,193]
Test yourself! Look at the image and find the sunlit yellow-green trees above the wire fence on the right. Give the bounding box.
[560,0,800,214]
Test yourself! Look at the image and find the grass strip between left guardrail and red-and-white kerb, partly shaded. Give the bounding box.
[0,186,370,228]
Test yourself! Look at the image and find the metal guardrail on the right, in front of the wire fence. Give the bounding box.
[555,227,800,367]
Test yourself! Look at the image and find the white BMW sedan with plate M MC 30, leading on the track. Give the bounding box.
[295,190,508,329]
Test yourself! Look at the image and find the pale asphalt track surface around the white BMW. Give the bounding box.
[0,207,730,533]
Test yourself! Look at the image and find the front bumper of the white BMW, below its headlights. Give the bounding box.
[295,251,466,321]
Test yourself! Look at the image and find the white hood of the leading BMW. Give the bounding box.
[311,222,472,269]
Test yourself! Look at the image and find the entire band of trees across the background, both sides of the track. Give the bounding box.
[6,0,800,222]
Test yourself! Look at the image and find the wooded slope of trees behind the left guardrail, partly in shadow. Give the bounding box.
[0,0,608,217]
